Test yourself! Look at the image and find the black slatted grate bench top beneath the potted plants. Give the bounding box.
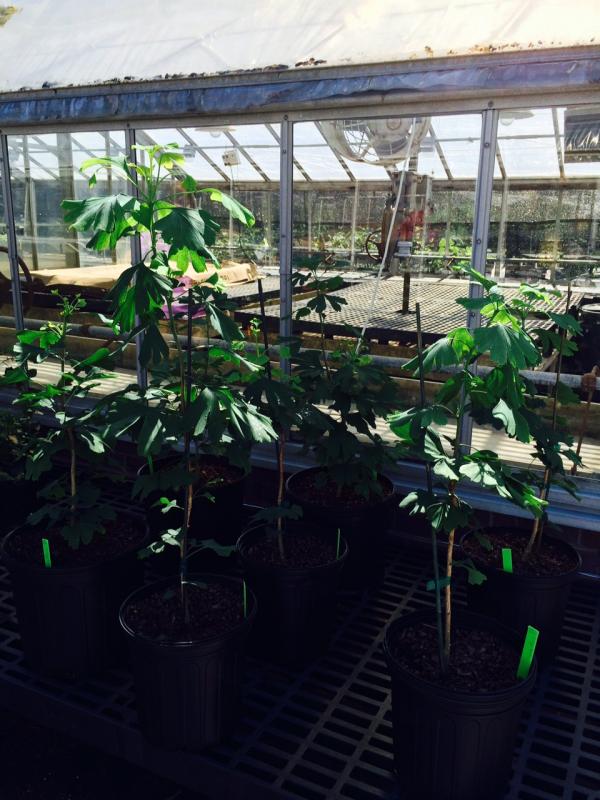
[0,540,600,800]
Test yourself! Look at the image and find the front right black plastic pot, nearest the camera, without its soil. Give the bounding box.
[383,610,537,800]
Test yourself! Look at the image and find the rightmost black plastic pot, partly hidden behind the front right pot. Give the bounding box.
[461,529,581,666]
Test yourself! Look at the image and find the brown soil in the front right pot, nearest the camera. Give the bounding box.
[390,624,519,694]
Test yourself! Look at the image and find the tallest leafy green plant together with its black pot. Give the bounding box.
[68,146,275,750]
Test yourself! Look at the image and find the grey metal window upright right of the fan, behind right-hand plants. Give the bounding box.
[456,109,498,451]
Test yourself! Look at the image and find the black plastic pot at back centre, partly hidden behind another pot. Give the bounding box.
[286,467,397,589]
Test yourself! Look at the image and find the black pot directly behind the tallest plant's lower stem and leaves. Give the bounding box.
[138,455,246,575]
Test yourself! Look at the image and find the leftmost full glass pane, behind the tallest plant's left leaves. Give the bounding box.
[2,131,135,370]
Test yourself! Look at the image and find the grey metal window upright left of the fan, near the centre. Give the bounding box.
[279,116,294,372]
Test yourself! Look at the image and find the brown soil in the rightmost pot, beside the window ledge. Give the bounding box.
[463,531,577,577]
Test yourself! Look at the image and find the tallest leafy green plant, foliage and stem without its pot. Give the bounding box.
[63,145,275,619]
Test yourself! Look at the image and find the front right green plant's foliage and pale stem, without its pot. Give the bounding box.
[390,268,578,673]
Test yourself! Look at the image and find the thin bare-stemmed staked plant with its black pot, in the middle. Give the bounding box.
[237,316,348,666]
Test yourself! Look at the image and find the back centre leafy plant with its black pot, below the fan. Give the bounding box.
[286,255,397,588]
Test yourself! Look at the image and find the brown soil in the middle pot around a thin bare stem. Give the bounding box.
[244,531,335,569]
